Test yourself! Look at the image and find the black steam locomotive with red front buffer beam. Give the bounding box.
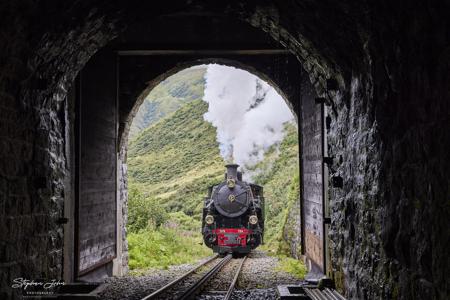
[202,164,264,254]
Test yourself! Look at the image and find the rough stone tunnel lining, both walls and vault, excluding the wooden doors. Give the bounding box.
[0,0,450,299]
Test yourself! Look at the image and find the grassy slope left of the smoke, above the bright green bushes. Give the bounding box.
[128,99,224,218]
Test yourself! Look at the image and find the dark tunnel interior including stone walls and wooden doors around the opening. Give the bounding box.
[0,0,450,299]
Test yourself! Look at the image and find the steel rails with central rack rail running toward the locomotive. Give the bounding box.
[141,254,246,300]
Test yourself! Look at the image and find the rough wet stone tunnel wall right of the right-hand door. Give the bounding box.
[322,4,450,299]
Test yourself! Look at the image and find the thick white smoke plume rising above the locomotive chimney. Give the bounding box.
[203,64,294,176]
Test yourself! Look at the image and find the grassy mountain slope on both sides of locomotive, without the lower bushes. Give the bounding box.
[128,108,299,241]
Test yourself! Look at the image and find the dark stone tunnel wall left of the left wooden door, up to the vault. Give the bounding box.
[0,1,120,299]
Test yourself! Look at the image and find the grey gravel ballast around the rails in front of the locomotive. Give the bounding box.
[99,251,299,300]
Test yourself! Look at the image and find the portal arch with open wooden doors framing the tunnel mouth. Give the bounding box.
[75,45,327,284]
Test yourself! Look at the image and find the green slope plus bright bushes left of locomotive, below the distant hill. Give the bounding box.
[127,99,224,273]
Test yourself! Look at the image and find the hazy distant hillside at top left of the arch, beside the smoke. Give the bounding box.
[130,67,206,140]
